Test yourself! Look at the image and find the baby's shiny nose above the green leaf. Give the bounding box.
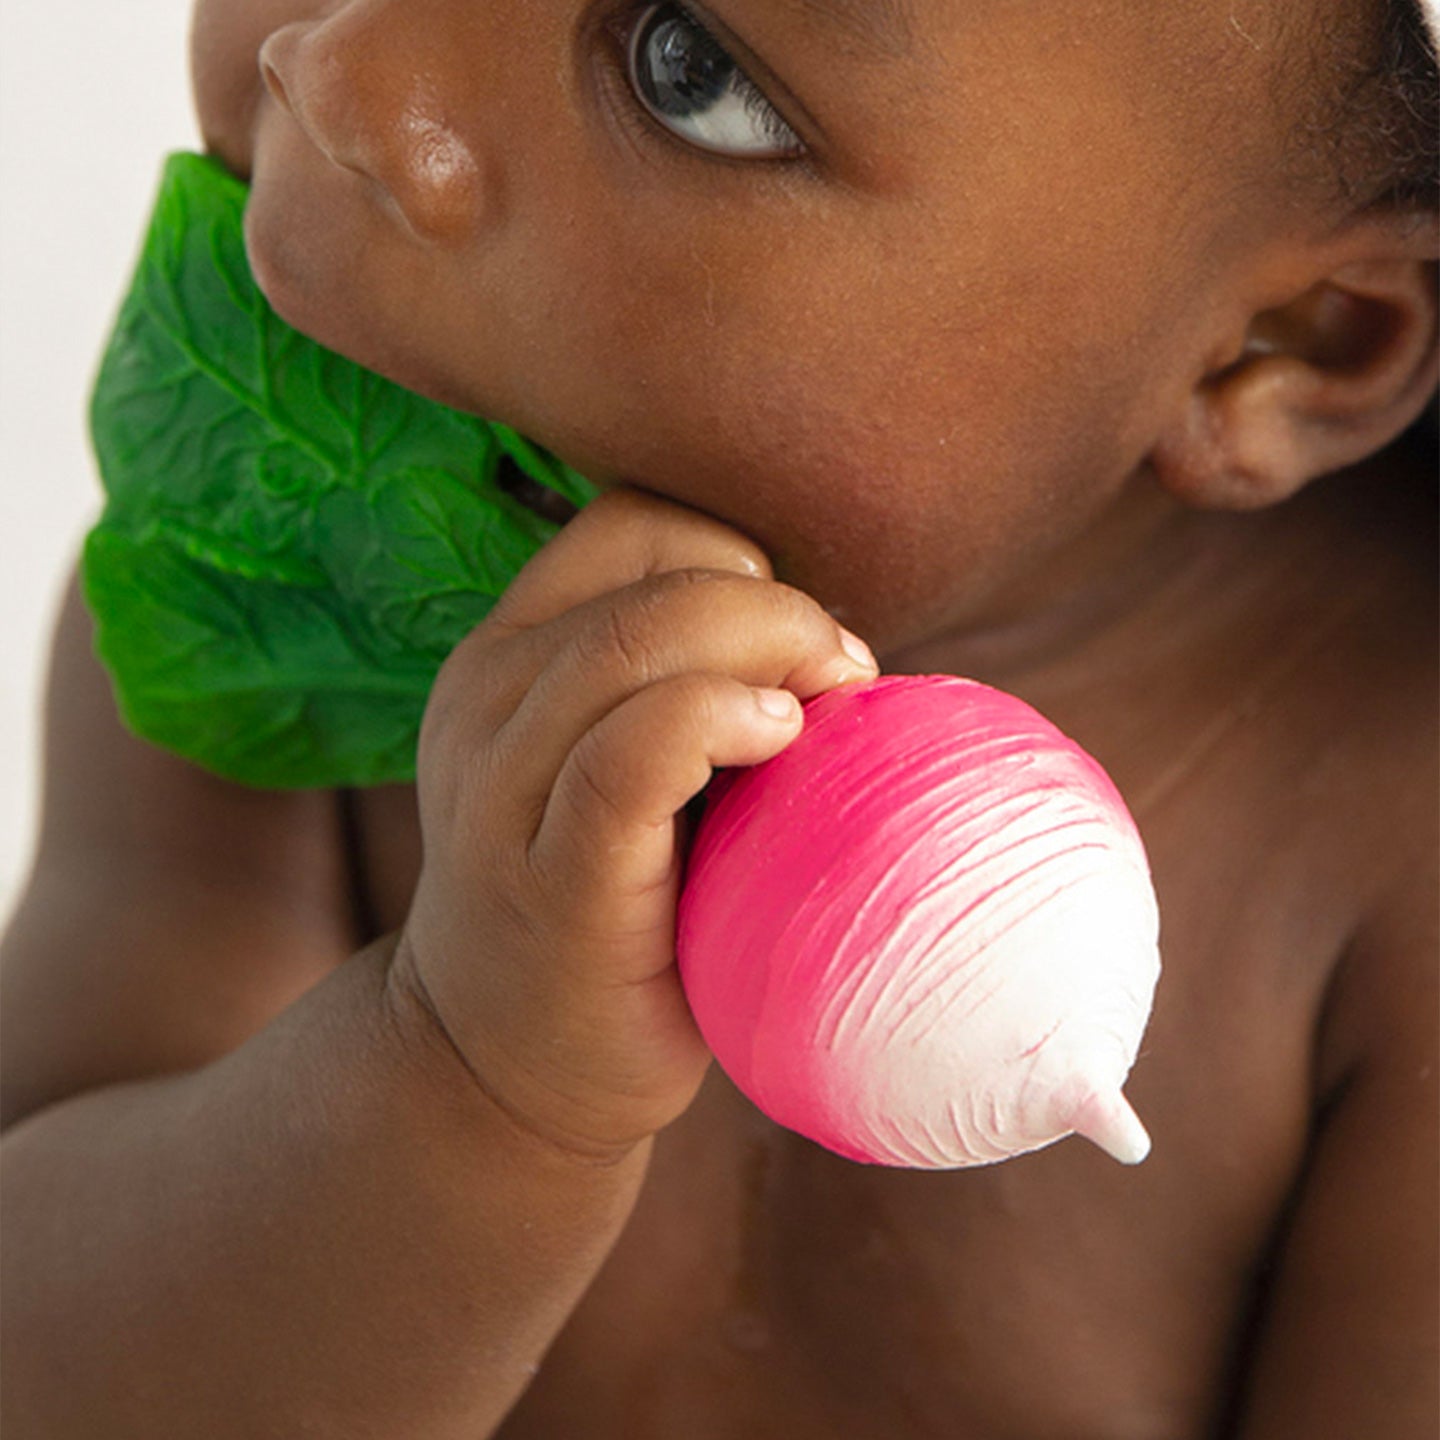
[259,0,498,245]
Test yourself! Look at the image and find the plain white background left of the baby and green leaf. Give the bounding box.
[0,0,199,926]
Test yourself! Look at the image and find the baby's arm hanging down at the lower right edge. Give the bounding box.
[1240,852,1440,1440]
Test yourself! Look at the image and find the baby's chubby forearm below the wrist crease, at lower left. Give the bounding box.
[3,946,647,1440]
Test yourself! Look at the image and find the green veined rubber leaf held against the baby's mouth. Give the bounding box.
[82,156,593,786]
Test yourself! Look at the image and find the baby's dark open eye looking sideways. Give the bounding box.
[629,4,805,160]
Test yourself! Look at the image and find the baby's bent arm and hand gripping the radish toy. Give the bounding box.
[3,495,867,1440]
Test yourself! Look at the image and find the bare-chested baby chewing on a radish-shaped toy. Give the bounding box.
[4,0,1440,1440]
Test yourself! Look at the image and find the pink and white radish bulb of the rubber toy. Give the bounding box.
[678,677,1159,1169]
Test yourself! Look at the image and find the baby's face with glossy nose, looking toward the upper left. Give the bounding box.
[196,0,1290,648]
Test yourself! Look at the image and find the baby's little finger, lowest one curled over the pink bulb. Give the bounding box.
[530,672,802,944]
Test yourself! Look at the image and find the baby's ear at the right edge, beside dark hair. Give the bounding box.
[1151,216,1440,510]
